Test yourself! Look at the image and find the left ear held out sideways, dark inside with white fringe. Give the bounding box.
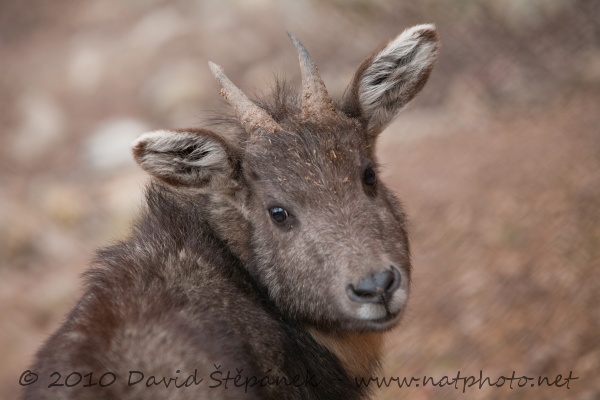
[132,129,240,189]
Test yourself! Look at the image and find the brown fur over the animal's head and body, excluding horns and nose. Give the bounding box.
[23,26,435,400]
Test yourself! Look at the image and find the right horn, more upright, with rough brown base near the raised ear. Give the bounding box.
[287,32,335,117]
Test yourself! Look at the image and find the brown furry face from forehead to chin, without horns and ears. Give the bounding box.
[244,116,410,329]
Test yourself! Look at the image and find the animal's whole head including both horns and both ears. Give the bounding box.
[133,25,438,331]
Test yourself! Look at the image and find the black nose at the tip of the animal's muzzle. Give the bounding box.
[346,265,402,303]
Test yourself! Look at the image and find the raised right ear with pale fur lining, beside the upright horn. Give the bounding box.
[342,24,439,135]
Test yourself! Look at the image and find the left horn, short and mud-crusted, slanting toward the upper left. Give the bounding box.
[208,62,281,134]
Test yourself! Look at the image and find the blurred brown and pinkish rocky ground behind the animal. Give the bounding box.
[0,0,600,400]
